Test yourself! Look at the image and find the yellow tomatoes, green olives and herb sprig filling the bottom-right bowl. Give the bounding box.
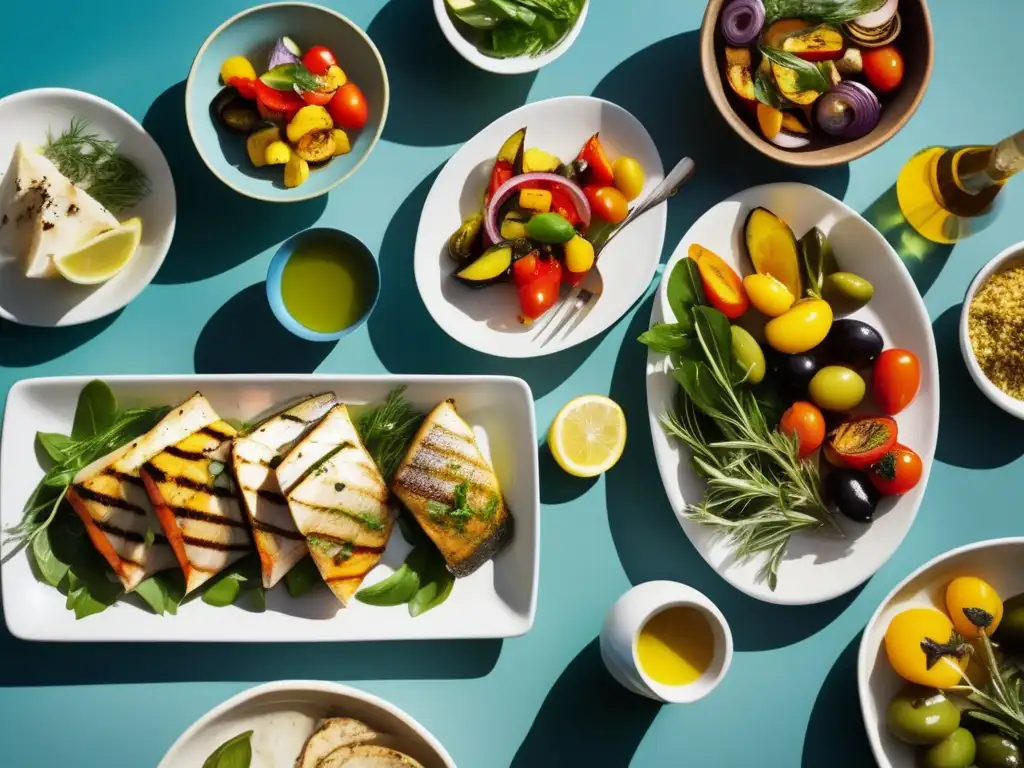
[885,575,1024,768]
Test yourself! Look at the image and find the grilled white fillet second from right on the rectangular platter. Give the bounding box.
[276,404,394,605]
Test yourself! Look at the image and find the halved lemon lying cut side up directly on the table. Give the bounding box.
[548,394,626,477]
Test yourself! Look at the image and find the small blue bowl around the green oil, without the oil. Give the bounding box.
[266,227,381,341]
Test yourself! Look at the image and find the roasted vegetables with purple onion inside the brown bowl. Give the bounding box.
[719,0,904,150]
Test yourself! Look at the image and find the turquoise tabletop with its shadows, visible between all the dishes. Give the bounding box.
[0,0,1024,768]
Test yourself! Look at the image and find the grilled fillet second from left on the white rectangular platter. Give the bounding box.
[141,408,253,593]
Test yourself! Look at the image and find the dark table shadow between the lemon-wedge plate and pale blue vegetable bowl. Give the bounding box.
[142,82,327,284]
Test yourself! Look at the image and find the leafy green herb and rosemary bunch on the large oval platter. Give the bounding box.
[640,259,839,590]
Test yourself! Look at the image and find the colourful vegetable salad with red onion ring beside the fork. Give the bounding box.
[447,128,645,325]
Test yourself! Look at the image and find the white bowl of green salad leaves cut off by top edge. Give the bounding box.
[433,0,590,75]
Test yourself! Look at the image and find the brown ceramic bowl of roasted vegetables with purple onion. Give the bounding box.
[700,0,933,166]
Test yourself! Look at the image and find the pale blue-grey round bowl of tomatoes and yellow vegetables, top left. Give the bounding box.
[185,3,389,203]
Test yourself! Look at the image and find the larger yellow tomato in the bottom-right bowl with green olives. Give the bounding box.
[886,608,969,688]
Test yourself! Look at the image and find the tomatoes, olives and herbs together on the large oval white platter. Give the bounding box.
[640,204,924,589]
